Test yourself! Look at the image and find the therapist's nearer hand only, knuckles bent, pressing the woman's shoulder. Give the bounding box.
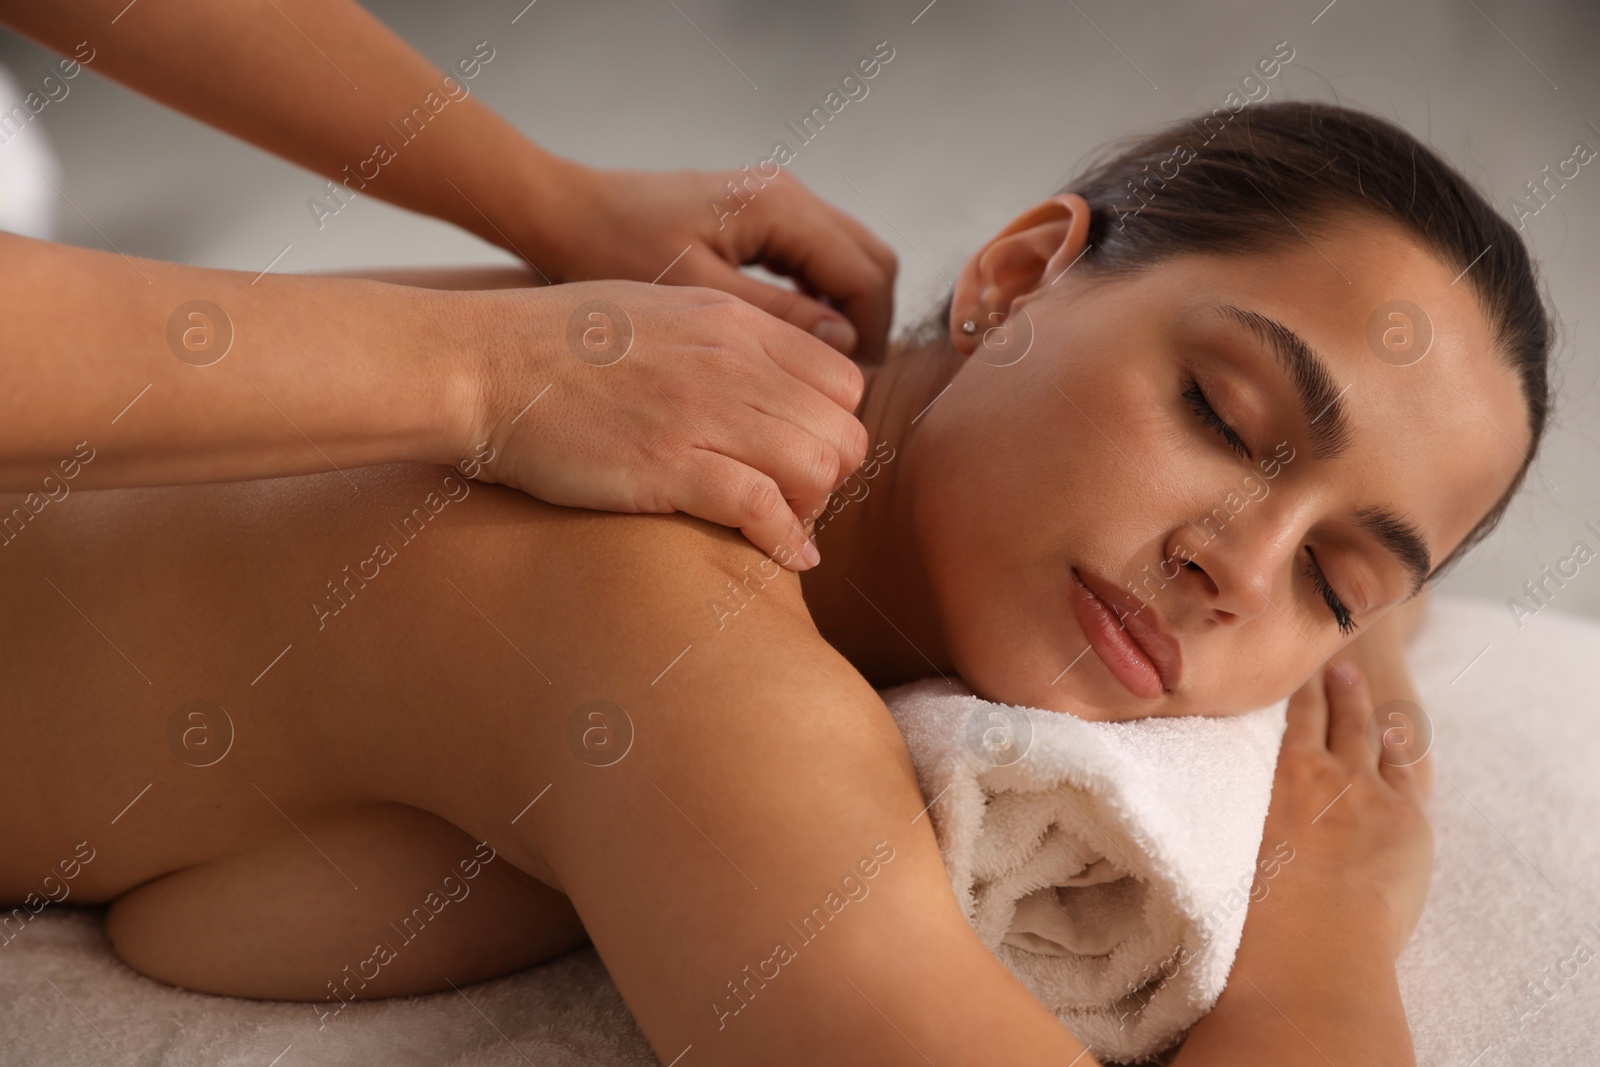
[457,282,867,569]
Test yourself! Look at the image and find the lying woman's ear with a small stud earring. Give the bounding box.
[949,192,1090,355]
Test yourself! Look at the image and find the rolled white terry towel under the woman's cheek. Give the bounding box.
[883,678,1293,1062]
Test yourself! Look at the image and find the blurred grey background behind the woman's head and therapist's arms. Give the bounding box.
[0,0,1600,635]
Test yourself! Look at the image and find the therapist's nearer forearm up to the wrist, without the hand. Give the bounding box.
[0,234,477,494]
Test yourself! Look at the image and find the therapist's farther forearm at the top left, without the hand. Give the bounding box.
[0,0,582,267]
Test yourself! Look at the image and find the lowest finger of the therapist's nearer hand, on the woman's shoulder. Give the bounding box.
[670,448,821,571]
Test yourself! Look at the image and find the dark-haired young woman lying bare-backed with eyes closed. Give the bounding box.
[0,104,1550,1065]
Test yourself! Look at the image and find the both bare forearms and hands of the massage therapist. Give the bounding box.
[0,0,894,558]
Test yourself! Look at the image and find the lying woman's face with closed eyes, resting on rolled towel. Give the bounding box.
[902,212,1528,720]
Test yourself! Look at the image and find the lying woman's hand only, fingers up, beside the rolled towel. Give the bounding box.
[1251,662,1434,958]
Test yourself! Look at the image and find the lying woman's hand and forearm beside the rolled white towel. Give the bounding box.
[1173,664,1434,1067]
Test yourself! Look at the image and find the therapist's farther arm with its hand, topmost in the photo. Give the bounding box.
[0,0,896,360]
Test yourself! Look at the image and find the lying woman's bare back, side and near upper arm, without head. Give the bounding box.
[0,467,1427,1062]
